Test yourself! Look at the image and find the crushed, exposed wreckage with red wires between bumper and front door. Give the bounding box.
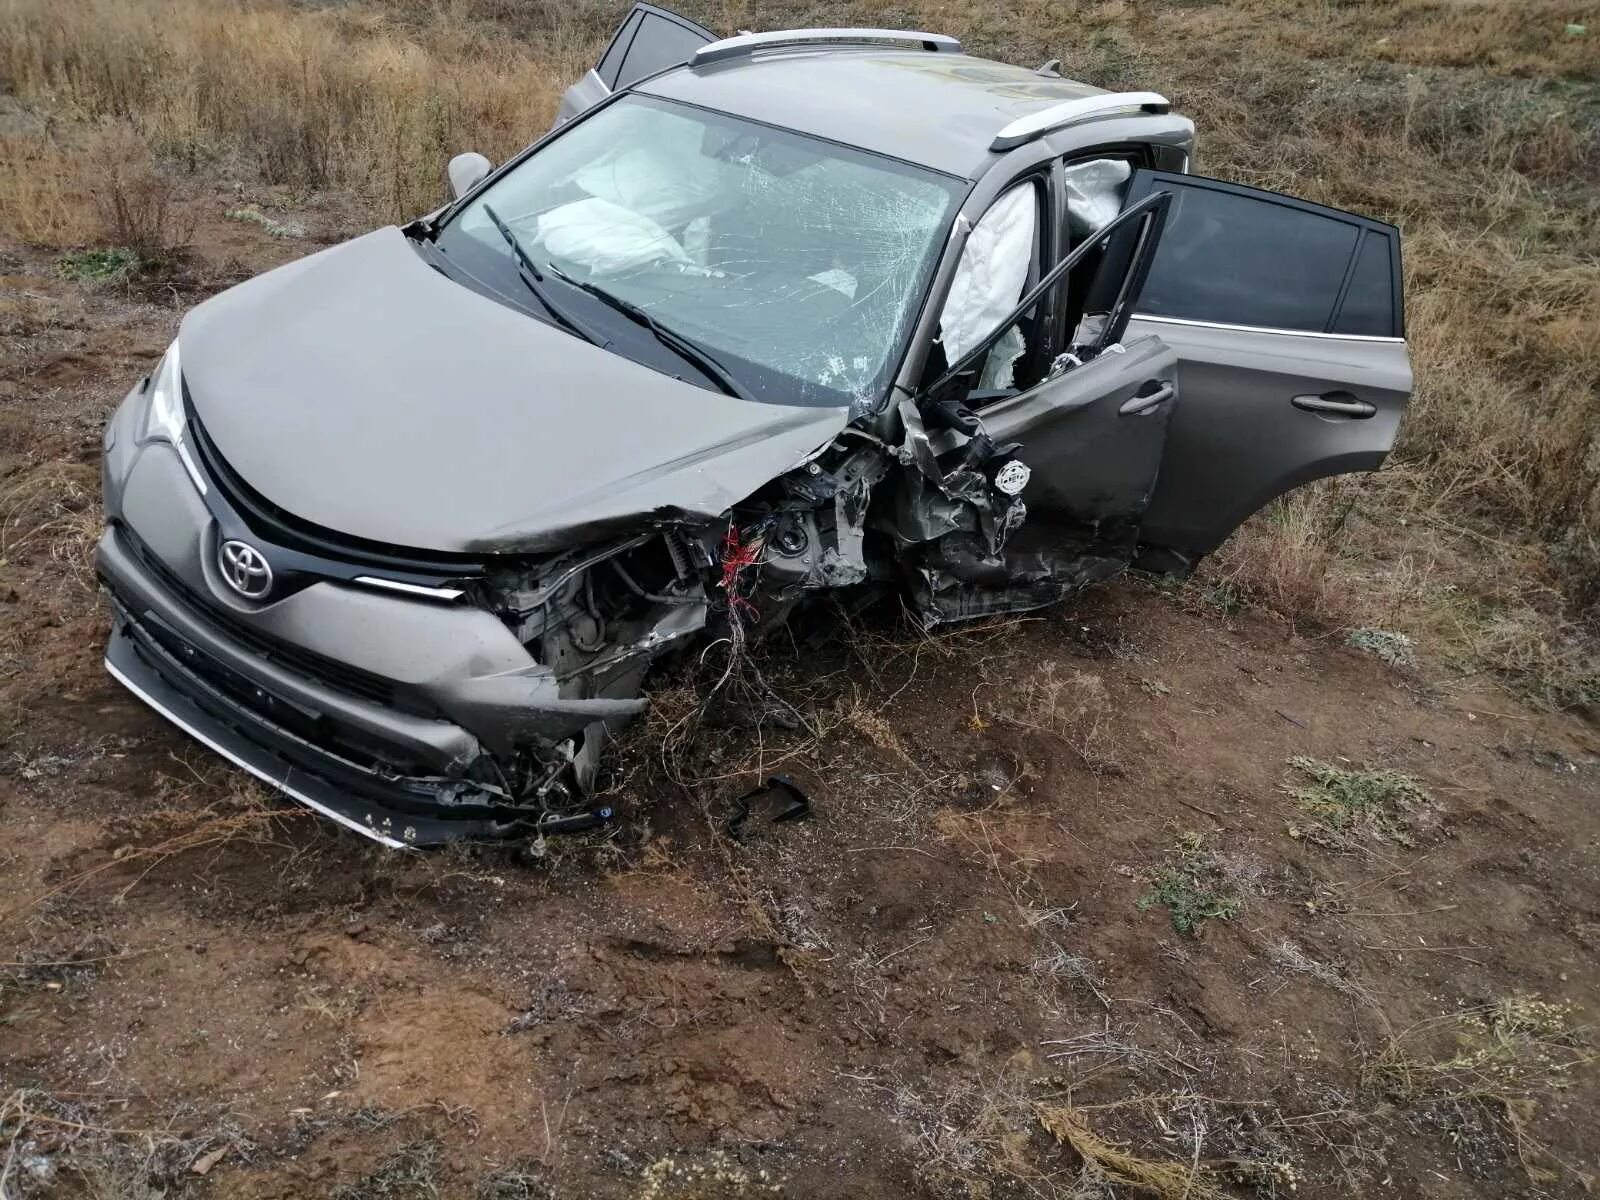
[457,387,1094,830]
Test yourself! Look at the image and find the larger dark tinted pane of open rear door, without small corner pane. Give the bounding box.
[1139,179,1362,333]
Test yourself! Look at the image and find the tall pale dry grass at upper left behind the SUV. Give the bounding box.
[0,0,581,219]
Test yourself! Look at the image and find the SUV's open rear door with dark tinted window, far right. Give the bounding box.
[1126,171,1411,570]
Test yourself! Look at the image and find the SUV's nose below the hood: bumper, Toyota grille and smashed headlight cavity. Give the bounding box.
[96,361,714,846]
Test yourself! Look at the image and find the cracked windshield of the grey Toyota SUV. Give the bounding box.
[438,96,966,411]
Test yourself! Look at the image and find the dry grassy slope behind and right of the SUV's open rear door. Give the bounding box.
[985,0,1600,706]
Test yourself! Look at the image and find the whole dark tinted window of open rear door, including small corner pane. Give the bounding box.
[1128,171,1402,338]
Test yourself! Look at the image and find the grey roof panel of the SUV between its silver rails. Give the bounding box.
[635,45,1104,179]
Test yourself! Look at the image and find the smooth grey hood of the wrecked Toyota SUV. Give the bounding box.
[179,227,850,552]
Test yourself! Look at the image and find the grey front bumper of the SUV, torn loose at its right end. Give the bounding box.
[96,422,643,846]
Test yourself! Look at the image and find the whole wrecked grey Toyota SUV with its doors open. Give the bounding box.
[98,16,1411,846]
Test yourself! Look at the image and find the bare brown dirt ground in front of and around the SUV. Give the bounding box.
[0,155,1600,1200]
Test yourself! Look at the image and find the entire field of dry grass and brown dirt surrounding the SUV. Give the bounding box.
[0,0,1600,1200]
